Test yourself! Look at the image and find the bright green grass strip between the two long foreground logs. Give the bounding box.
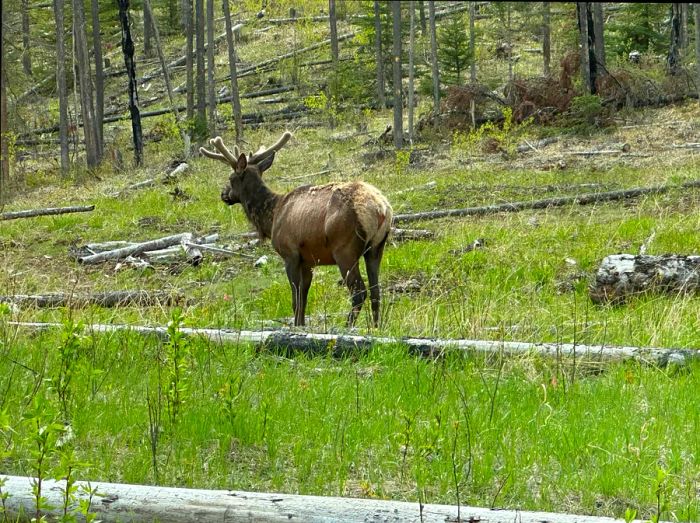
[0,329,700,521]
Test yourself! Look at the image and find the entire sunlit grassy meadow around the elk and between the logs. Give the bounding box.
[0,99,700,521]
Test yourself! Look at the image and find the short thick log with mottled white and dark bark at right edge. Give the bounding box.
[589,254,700,303]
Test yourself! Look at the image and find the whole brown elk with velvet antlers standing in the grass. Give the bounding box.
[199,132,393,327]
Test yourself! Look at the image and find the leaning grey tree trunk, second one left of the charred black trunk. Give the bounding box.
[73,0,99,169]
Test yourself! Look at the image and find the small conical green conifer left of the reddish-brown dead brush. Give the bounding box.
[438,16,473,85]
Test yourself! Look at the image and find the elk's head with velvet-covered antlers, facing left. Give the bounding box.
[199,132,292,205]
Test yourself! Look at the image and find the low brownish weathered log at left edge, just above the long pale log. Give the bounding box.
[0,290,183,307]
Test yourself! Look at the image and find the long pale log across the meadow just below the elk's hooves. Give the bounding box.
[9,322,700,366]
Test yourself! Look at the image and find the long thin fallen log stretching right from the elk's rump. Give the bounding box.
[394,180,700,223]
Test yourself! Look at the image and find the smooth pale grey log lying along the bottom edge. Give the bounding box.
[0,476,664,523]
